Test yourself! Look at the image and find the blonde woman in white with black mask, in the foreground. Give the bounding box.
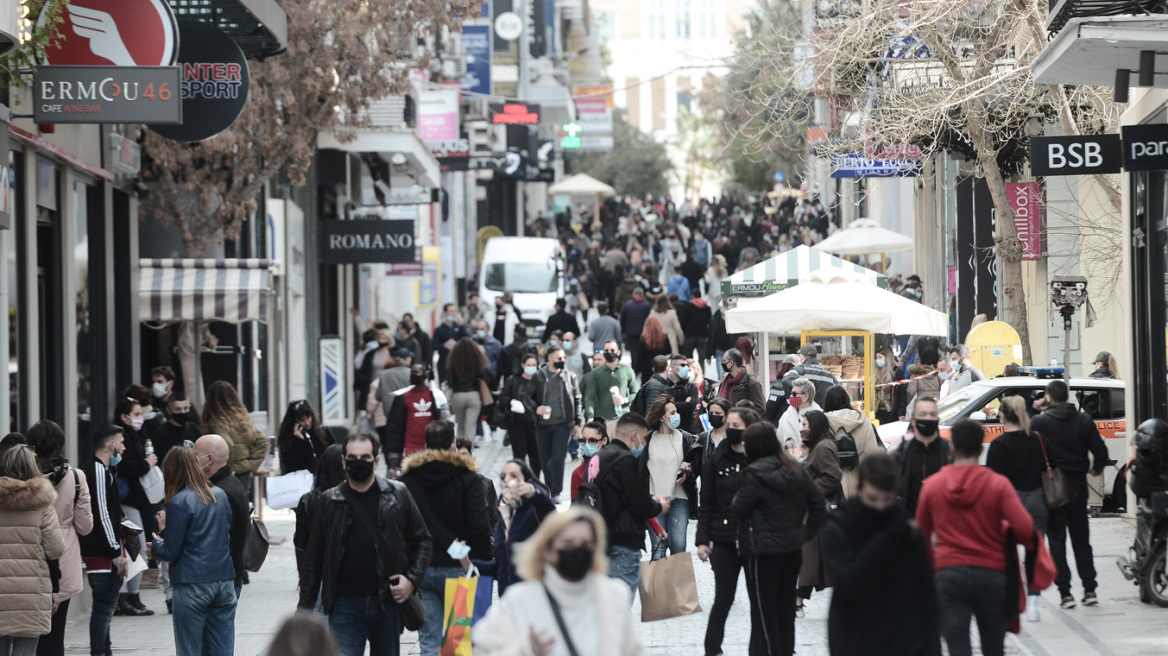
[473,507,642,656]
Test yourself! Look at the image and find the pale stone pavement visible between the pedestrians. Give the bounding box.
[65,431,1168,656]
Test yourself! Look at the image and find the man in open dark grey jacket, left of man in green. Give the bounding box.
[534,347,584,502]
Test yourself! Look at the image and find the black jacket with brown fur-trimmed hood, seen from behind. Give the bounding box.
[401,448,494,567]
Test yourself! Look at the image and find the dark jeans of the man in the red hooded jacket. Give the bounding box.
[934,567,1007,656]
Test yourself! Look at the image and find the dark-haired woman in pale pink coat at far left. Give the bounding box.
[28,419,93,656]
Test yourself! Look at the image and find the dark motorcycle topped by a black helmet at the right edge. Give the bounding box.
[1115,419,1168,608]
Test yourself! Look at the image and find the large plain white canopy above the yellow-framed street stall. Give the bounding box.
[726,270,948,337]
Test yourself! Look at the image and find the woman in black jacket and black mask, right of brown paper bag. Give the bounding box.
[694,399,760,656]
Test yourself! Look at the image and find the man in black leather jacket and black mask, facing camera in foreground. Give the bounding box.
[299,433,433,656]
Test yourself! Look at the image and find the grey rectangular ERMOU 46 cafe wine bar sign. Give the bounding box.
[33,67,182,125]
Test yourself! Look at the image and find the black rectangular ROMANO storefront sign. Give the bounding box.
[320,218,417,264]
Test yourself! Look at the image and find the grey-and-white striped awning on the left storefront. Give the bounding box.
[138,259,272,323]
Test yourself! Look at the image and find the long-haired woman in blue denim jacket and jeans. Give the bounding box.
[150,446,237,656]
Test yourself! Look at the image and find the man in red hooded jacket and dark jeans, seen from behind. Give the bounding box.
[917,419,1034,656]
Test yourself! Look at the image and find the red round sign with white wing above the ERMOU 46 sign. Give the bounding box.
[40,0,179,67]
